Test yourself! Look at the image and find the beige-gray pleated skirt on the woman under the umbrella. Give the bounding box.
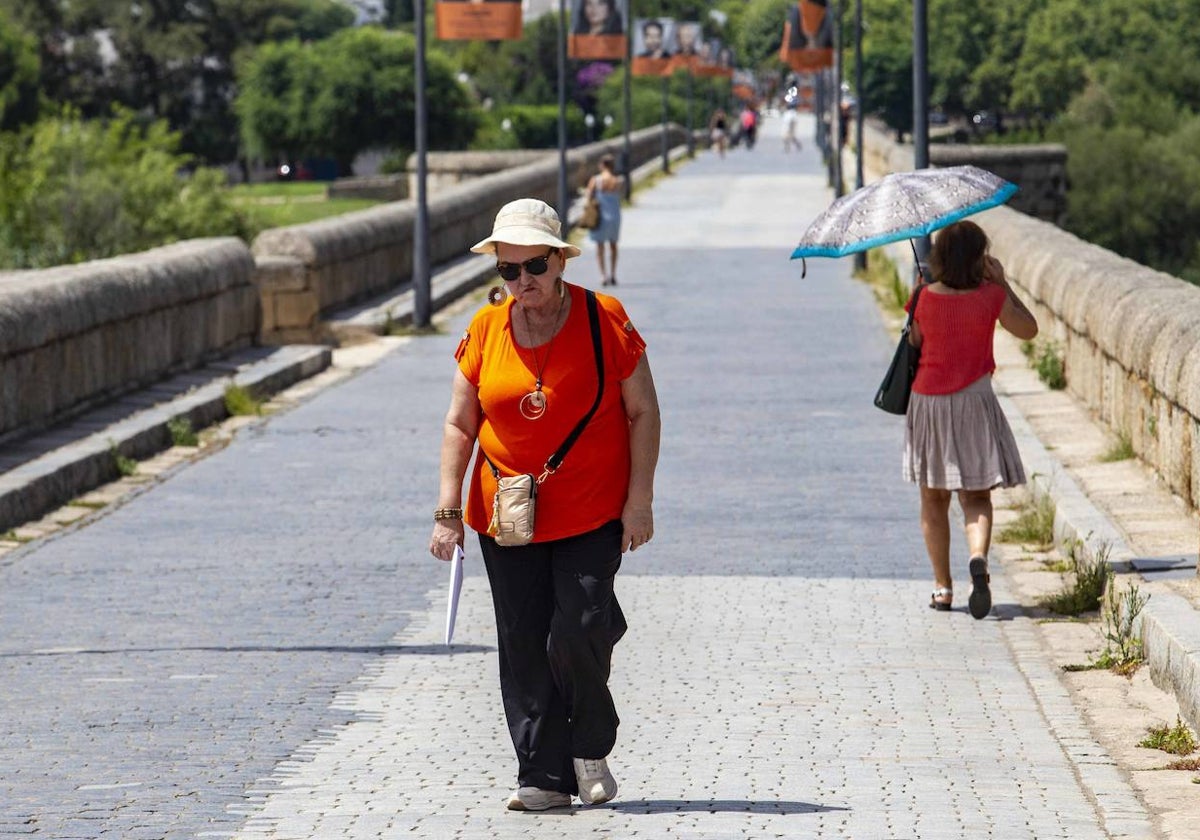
[904,376,1025,490]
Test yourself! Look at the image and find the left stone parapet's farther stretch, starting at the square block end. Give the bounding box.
[252,126,686,342]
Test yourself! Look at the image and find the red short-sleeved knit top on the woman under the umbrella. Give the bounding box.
[905,283,1008,395]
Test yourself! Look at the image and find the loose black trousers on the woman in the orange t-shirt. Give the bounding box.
[479,520,626,793]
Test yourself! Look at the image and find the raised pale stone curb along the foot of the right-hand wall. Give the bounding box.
[1000,396,1200,730]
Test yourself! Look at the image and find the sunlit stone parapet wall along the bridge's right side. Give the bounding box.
[846,121,1200,509]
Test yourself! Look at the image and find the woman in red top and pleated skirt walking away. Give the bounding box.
[904,221,1038,618]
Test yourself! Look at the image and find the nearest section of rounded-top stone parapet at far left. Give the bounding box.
[0,238,259,440]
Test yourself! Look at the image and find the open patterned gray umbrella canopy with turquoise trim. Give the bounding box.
[792,167,1016,259]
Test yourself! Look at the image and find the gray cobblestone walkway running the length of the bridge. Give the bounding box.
[0,122,1153,840]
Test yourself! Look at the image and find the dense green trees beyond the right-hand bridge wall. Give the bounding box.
[863,0,1200,282]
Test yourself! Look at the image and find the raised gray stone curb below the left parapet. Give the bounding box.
[0,344,332,530]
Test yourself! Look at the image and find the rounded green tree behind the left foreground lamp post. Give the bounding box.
[235,26,479,172]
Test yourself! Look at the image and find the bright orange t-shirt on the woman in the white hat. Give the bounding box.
[455,283,646,542]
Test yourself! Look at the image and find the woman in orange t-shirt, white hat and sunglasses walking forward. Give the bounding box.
[430,198,660,811]
